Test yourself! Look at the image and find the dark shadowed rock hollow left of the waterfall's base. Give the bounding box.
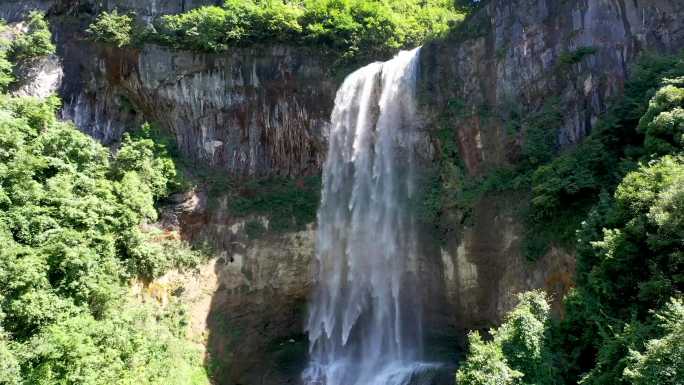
[205,257,308,385]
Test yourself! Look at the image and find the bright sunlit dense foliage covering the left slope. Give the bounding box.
[0,91,207,385]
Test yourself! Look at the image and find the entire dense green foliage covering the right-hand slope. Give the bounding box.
[458,57,684,385]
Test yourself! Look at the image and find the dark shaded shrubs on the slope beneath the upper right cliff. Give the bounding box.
[524,52,684,260]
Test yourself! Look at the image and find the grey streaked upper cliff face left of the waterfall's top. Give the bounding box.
[63,43,336,176]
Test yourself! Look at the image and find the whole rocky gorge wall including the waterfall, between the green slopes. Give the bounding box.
[0,0,684,385]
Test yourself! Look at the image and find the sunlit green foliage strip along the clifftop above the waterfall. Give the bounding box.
[90,0,463,64]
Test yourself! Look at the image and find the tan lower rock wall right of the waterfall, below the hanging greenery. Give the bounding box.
[439,195,575,335]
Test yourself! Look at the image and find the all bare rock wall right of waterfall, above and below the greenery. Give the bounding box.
[420,0,684,329]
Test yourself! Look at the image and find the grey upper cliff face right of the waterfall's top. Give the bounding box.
[421,0,684,173]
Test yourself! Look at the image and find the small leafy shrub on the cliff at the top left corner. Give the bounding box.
[11,11,56,61]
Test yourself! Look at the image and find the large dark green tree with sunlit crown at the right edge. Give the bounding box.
[536,156,684,384]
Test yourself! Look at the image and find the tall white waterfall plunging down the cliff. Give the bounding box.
[303,49,438,385]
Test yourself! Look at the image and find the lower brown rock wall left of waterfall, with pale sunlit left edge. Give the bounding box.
[160,190,315,385]
